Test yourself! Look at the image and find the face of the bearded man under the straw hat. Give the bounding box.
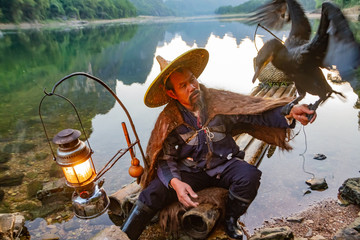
[166,69,201,111]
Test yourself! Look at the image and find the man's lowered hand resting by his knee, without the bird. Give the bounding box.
[170,178,199,208]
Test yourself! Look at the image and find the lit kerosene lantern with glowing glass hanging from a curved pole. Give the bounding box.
[53,129,110,219]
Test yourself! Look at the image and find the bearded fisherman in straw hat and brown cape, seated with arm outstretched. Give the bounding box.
[122,48,315,240]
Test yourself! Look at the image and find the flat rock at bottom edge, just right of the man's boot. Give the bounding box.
[249,227,294,240]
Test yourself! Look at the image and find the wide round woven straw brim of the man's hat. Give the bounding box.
[144,48,209,108]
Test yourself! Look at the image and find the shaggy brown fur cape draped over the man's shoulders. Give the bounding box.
[141,84,292,188]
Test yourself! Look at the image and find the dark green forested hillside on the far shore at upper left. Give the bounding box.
[0,0,136,23]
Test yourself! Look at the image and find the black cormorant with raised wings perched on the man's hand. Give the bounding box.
[251,0,360,119]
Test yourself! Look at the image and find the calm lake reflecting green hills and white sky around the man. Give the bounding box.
[0,17,360,239]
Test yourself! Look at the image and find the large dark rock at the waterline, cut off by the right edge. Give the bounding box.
[339,178,360,205]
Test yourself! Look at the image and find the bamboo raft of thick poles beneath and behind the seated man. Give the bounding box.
[109,83,296,240]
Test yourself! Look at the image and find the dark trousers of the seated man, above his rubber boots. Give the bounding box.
[139,160,261,211]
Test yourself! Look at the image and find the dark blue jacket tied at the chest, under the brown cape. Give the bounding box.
[157,103,295,186]
